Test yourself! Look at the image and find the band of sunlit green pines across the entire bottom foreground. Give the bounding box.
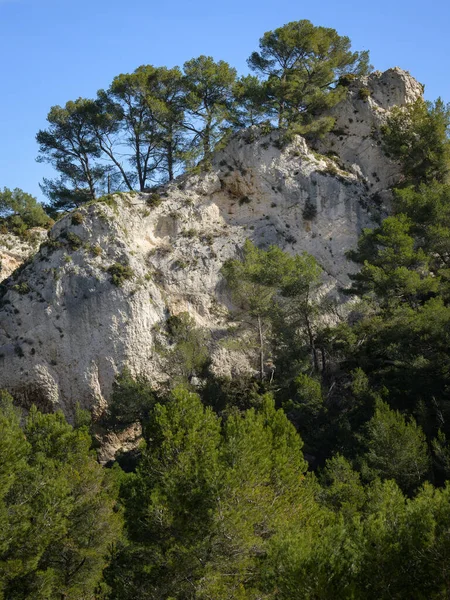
[4,376,450,600]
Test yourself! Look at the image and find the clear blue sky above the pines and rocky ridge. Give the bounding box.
[0,0,450,200]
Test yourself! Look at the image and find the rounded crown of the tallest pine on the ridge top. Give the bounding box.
[248,20,369,132]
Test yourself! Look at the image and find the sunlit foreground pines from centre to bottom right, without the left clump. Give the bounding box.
[106,388,450,599]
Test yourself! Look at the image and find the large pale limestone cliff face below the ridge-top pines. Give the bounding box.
[0,69,422,419]
